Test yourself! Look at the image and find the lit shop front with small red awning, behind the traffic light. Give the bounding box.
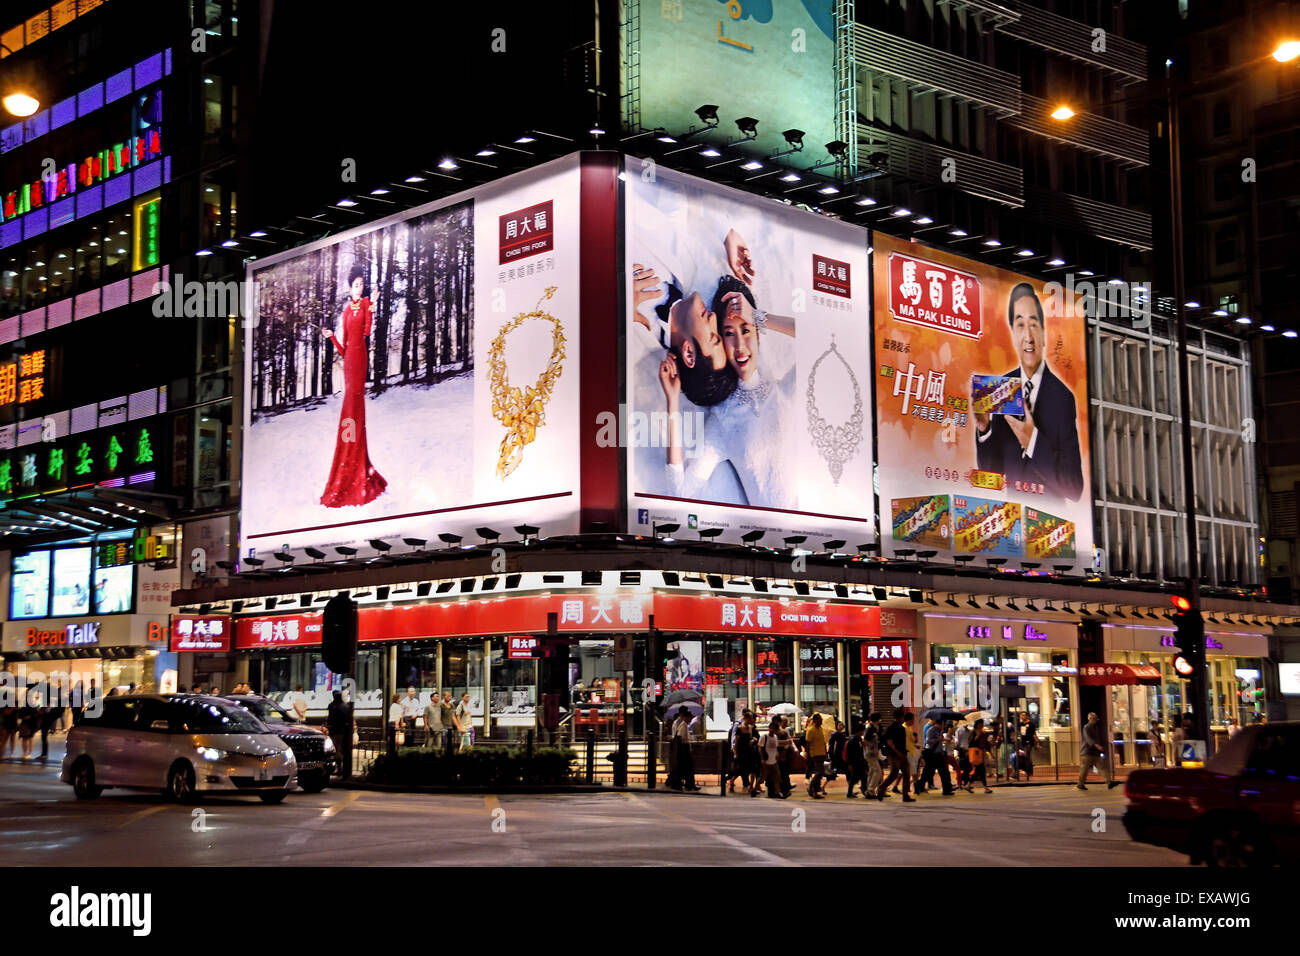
[1101,624,1269,766]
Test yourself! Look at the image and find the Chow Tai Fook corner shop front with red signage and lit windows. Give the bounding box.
[234,591,915,740]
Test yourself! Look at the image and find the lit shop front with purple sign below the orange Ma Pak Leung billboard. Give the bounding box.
[923,609,1079,763]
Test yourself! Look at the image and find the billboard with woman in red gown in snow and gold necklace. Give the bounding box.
[242,156,580,555]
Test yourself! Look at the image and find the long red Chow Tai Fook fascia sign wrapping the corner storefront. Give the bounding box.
[235,594,917,649]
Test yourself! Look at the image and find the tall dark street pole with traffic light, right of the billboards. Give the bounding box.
[1167,82,1210,750]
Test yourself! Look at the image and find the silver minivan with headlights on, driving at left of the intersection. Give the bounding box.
[60,693,298,804]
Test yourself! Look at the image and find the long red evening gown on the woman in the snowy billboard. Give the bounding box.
[321,298,389,507]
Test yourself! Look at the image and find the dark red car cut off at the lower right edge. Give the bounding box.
[1125,722,1300,866]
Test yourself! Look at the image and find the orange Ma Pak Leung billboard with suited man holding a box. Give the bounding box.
[874,233,1092,568]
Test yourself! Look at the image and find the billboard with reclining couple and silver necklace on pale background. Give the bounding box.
[623,159,874,544]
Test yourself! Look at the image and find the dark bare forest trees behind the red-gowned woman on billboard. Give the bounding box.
[248,200,475,421]
